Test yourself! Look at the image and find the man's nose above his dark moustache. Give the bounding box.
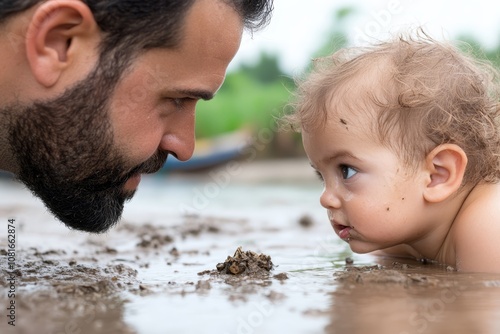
[160,108,195,161]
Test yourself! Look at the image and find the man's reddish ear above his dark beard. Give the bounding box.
[26,0,99,87]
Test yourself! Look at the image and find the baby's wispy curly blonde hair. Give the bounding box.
[284,31,500,185]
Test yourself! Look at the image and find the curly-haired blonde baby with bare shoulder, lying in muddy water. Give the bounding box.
[285,34,500,272]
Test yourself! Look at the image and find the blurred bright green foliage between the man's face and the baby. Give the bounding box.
[196,53,295,156]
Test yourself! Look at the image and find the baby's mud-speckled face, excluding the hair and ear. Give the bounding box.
[302,114,429,253]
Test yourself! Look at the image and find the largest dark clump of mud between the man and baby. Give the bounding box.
[216,246,274,276]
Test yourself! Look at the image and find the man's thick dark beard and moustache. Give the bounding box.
[2,60,168,233]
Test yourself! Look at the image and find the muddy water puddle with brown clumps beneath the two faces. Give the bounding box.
[0,165,500,334]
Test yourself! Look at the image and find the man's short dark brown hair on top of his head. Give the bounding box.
[0,0,273,87]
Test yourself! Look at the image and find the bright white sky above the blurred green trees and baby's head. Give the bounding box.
[230,0,500,75]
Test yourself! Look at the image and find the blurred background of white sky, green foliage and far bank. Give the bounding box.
[181,0,500,168]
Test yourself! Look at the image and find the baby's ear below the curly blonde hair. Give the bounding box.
[424,144,467,203]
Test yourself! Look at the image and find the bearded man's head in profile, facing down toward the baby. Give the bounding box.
[0,0,272,232]
